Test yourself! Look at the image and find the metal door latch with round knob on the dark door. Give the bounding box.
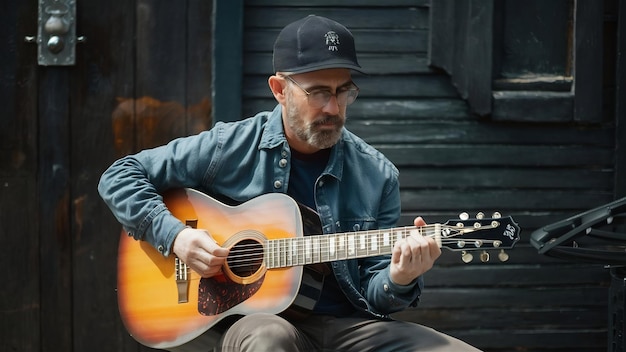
[24,0,85,66]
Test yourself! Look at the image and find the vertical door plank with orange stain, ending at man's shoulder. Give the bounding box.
[136,0,188,150]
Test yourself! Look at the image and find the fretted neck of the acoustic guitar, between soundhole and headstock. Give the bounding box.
[264,224,443,269]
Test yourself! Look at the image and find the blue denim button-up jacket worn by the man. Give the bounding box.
[98,105,423,318]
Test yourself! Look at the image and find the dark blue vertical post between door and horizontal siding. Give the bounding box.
[212,0,245,123]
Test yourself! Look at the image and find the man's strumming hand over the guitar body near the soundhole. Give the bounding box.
[172,228,230,277]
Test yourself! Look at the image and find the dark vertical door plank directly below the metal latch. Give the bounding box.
[37,66,73,351]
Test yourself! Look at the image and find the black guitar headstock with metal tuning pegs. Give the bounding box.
[441,213,520,263]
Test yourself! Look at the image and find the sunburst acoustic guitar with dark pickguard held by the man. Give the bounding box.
[117,188,520,351]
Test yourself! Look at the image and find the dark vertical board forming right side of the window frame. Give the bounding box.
[573,0,604,123]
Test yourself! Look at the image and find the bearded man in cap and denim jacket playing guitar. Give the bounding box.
[99,16,477,352]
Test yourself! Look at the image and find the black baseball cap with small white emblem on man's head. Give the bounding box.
[273,15,363,74]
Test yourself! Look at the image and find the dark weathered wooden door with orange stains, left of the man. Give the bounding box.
[0,0,212,351]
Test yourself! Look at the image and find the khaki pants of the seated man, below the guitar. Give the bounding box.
[218,314,479,352]
